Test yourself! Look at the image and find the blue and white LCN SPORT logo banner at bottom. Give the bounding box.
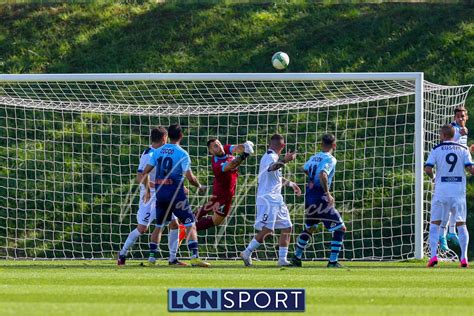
[168,289,306,312]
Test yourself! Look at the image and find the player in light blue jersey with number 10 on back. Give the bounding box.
[143,124,209,267]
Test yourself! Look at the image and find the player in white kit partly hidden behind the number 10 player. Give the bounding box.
[117,126,186,265]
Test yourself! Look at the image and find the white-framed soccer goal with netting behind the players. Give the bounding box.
[0,73,470,260]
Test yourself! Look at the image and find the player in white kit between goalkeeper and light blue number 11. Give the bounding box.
[240,134,301,266]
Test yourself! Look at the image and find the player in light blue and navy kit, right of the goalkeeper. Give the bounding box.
[291,134,346,268]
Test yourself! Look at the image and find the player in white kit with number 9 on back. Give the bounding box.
[425,125,474,268]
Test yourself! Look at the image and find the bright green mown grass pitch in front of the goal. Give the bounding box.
[0,261,474,315]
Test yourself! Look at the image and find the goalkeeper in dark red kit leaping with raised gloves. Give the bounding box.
[196,138,254,231]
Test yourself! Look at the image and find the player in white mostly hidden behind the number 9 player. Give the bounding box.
[439,106,474,251]
